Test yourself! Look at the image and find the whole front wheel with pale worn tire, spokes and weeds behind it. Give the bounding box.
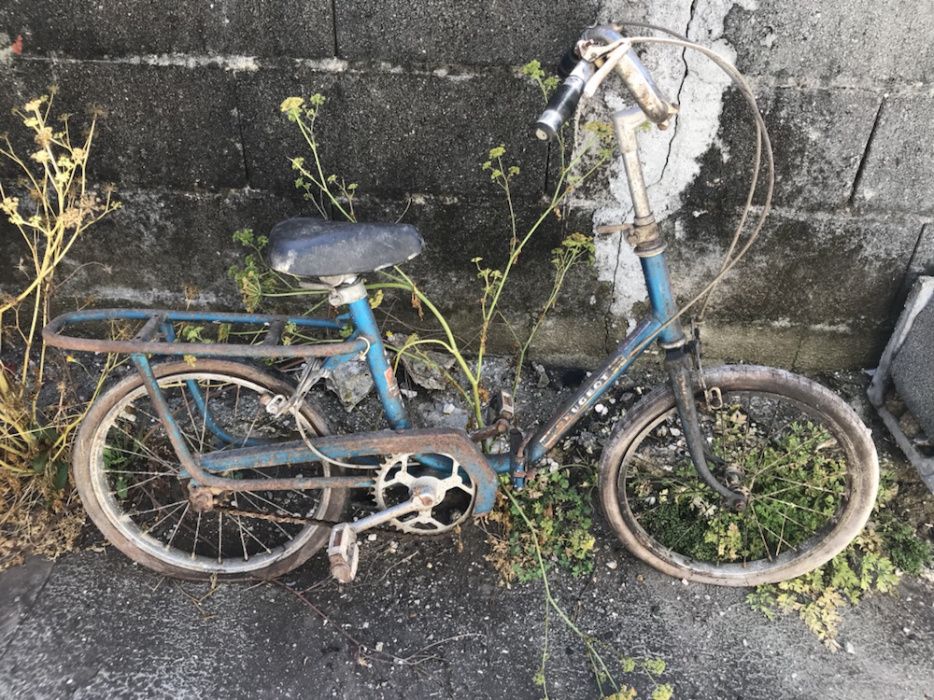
[601,366,879,586]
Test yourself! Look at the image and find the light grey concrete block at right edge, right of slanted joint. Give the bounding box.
[856,95,934,213]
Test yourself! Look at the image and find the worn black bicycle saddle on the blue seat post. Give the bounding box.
[269,217,424,277]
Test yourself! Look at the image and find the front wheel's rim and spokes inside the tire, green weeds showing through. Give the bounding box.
[616,391,852,579]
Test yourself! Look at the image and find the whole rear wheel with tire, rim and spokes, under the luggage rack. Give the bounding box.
[74,360,347,579]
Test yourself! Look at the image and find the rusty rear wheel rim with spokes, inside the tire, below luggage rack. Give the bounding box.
[90,371,331,574]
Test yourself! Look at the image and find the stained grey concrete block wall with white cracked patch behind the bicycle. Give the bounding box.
[0,0,934,368]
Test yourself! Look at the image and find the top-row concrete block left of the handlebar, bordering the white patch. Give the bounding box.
[336,0,599,65]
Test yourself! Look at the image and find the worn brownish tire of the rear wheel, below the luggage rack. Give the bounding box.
[72,360,348,580]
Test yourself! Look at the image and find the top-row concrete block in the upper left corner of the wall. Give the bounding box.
[0,0,334,58]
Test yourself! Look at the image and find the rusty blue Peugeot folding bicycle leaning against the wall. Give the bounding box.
[43,24,878,586]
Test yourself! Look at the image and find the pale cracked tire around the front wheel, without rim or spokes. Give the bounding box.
[600,365,879,586]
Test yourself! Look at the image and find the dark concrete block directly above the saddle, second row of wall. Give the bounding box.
[237,66,547,199]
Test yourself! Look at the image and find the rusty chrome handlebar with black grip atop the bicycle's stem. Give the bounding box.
[535,24,678,140]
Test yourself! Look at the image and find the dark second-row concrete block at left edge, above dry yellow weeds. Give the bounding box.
[0,60,246,189]
